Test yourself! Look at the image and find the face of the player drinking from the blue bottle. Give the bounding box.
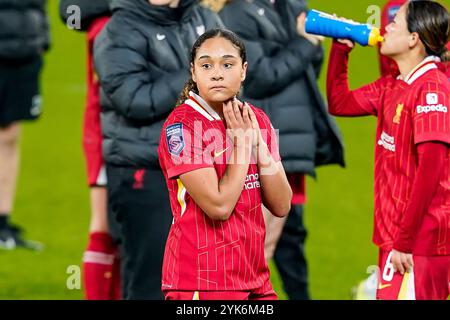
[381,4,411,58]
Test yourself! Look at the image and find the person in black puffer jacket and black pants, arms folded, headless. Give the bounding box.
[94,0,221,299]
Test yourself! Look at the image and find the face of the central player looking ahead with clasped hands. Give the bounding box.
[191,37,247,107]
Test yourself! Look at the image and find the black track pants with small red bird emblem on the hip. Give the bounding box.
[107,165,172,300]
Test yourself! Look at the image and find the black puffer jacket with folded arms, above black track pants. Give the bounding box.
[94,0,222,168]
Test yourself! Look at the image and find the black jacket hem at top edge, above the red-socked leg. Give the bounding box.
[59,0,111,31]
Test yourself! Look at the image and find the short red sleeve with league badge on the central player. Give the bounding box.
[159,121,214,179]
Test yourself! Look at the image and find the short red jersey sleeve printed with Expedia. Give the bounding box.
[413,82,450,144]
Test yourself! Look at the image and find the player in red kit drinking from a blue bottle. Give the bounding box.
[327,1,450,299]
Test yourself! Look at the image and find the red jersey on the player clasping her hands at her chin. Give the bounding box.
[158,92,280,291]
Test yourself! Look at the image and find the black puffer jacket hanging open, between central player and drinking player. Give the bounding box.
[219,0,344,176]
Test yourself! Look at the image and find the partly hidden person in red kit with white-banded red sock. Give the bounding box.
[59,0,120,300]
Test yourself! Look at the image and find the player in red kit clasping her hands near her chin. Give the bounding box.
[158,29,292,300]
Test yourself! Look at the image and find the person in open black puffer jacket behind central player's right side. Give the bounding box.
[219,0,344,300]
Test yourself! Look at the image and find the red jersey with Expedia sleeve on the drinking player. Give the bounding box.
[347,57,450,255]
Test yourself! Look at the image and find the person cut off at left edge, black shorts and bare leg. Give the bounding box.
[0,0,50,250]
